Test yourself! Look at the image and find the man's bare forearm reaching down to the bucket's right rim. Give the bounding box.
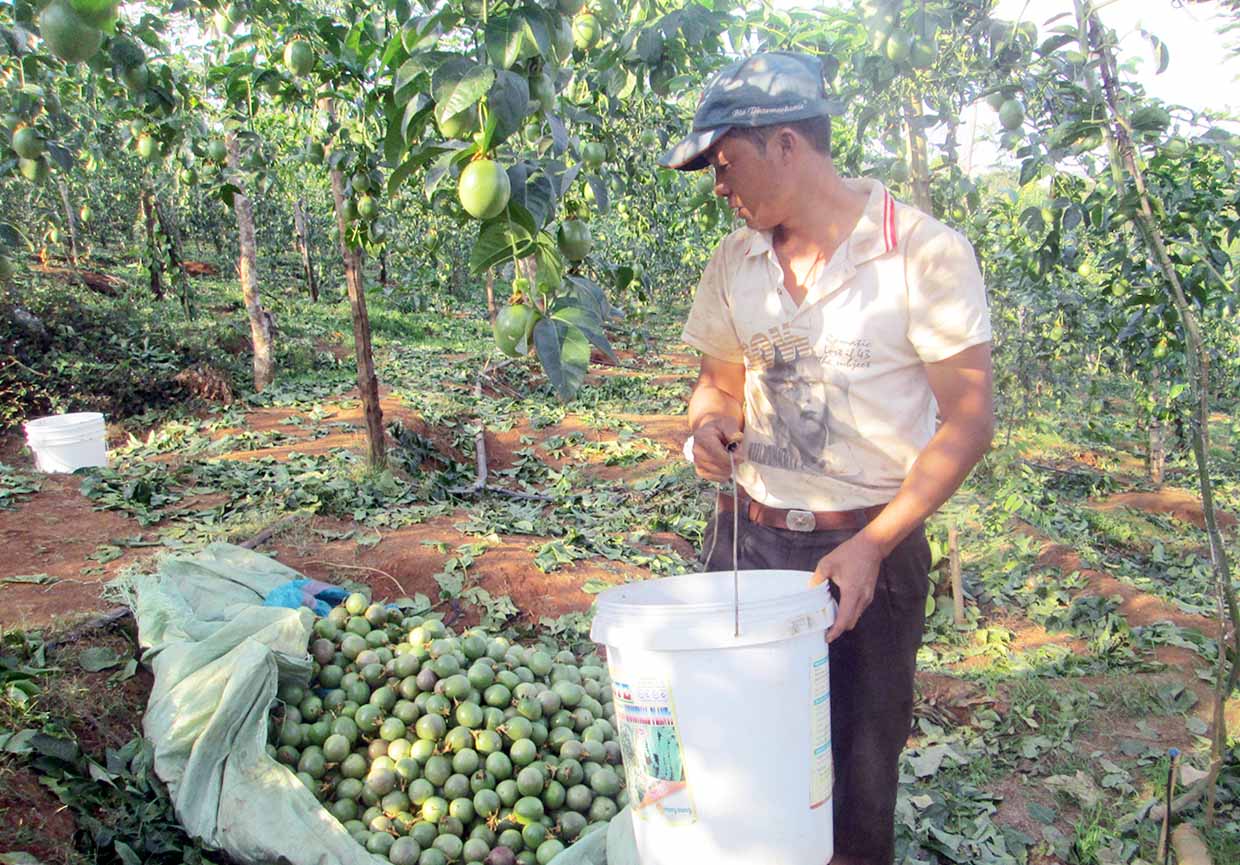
[859,415,993,558]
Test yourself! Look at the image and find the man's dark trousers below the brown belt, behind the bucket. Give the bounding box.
[704,505,930,865]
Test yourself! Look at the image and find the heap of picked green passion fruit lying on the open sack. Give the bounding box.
[268,592,627,865]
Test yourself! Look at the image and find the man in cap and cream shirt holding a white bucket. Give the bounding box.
[661,53,993,865]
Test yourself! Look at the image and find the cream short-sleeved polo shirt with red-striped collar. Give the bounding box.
[683,180,991,511]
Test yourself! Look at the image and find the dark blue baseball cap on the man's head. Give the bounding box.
[658,51,843,171]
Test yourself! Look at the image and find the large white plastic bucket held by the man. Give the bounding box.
[590,570,835,865]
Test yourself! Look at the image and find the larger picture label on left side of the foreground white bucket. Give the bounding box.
[611,674,697,825]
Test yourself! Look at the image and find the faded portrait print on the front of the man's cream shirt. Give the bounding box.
[745,338,868,478]
